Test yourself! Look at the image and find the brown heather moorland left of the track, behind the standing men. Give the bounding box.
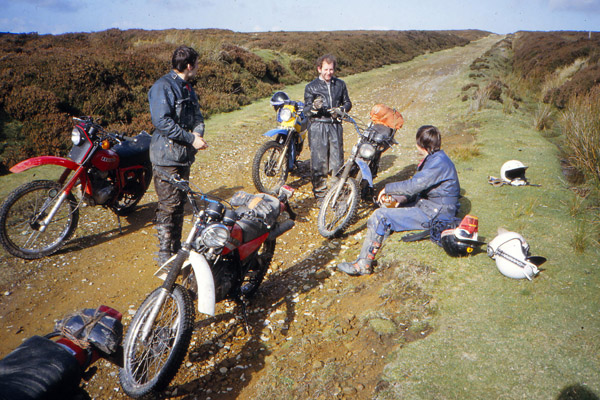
[0,29,487,173]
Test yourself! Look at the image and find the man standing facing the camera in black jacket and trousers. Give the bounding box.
[304,54,352,201]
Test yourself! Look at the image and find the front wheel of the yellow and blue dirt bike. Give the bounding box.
[252,141,289,194]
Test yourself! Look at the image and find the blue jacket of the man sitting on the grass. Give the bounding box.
[385,150,460,218]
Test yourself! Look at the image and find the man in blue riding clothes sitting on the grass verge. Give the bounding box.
[337,125,460,275]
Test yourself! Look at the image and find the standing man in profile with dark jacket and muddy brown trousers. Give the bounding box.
[148,46,208,265]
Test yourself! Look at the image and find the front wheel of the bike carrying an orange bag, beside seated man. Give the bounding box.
[317,178,359,238]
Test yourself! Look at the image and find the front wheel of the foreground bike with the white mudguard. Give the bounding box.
[119,285,195,398]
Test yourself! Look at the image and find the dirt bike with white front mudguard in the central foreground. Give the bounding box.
[119,176,295,398]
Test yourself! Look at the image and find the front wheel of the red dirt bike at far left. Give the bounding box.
[0,181,79,260]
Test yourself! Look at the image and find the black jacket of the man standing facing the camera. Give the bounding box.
[304,77,352,119]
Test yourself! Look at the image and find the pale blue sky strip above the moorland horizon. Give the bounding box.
[0,0,600,34]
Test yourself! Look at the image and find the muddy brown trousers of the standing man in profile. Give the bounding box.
[154,166,190,265]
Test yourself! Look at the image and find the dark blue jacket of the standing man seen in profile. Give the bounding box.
[148,71,204,166]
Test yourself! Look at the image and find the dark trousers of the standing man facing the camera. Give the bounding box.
[308,121,344,198]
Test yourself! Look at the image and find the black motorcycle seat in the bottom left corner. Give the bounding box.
[0,336,81,400]
